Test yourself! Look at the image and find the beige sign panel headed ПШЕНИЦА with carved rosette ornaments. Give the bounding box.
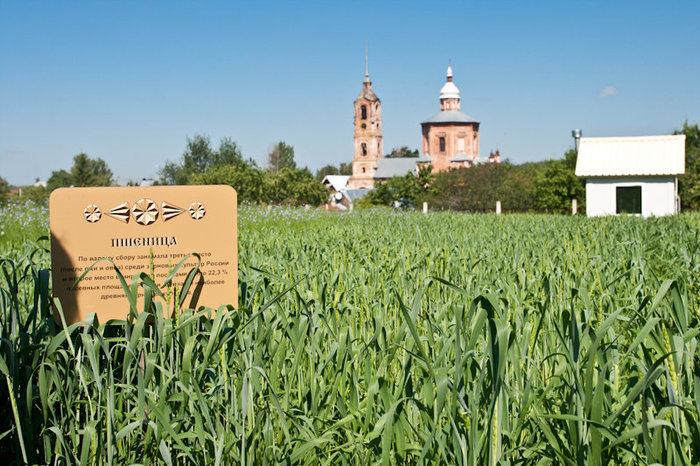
[49,186,238,323]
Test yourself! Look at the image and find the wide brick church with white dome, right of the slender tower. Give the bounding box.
[421,66,484,172]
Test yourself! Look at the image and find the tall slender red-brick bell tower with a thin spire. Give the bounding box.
[348,53,384,189]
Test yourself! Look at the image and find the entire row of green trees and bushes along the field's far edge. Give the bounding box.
[0,121,700,213]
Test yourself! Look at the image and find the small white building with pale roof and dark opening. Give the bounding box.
[576,135,685,217]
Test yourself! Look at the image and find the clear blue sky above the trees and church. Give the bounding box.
[0,0,700,184]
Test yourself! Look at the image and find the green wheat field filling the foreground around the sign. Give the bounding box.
[0,201,700,465]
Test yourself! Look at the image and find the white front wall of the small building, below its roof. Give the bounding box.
[586,177,676,217]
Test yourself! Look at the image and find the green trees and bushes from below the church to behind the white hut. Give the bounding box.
[360,121,700,213]
